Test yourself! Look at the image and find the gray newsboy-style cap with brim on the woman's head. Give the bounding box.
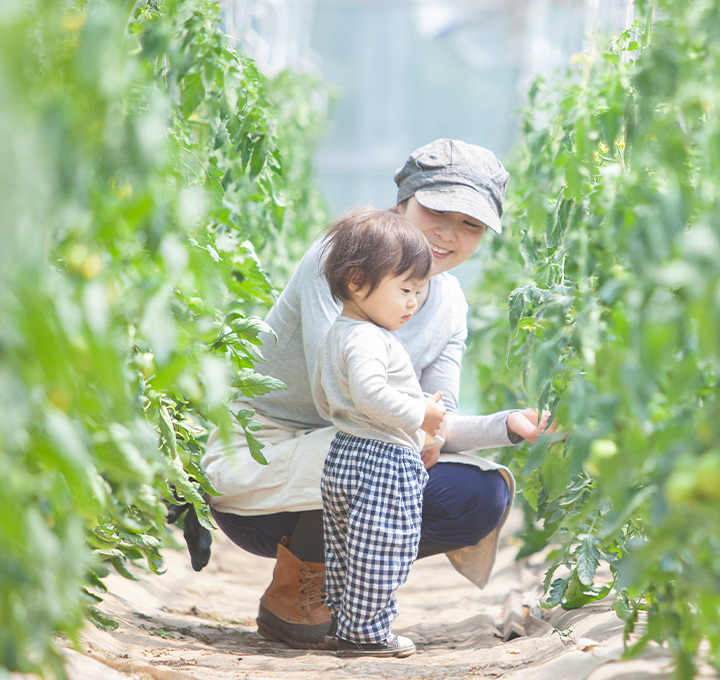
[395,139,510,234]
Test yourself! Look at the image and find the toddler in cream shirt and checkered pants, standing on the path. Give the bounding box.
[313,209,445,657]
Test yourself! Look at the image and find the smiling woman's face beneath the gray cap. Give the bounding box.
[398,196,486,276]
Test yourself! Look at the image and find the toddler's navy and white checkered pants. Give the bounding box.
[322,432,428,642]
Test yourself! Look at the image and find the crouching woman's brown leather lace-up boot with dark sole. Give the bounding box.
[257,539,331,649]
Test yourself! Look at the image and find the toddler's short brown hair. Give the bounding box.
[322,208,432,301]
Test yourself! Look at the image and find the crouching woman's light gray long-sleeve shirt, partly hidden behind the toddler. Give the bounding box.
[246,242,517,451]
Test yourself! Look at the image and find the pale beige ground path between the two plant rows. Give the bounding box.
[28,512,715,680]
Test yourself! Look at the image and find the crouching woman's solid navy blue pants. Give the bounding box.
[212,463,510,561]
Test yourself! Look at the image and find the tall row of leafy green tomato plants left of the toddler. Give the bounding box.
[0,0,321,676]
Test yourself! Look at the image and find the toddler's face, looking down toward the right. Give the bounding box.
[343,274,427,331]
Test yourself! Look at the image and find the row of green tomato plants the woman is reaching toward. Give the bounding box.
[472,0,720,678]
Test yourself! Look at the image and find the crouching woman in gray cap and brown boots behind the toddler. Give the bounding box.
[203,139,549,648]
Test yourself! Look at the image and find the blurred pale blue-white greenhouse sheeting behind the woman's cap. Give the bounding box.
[224,0,633,212]
